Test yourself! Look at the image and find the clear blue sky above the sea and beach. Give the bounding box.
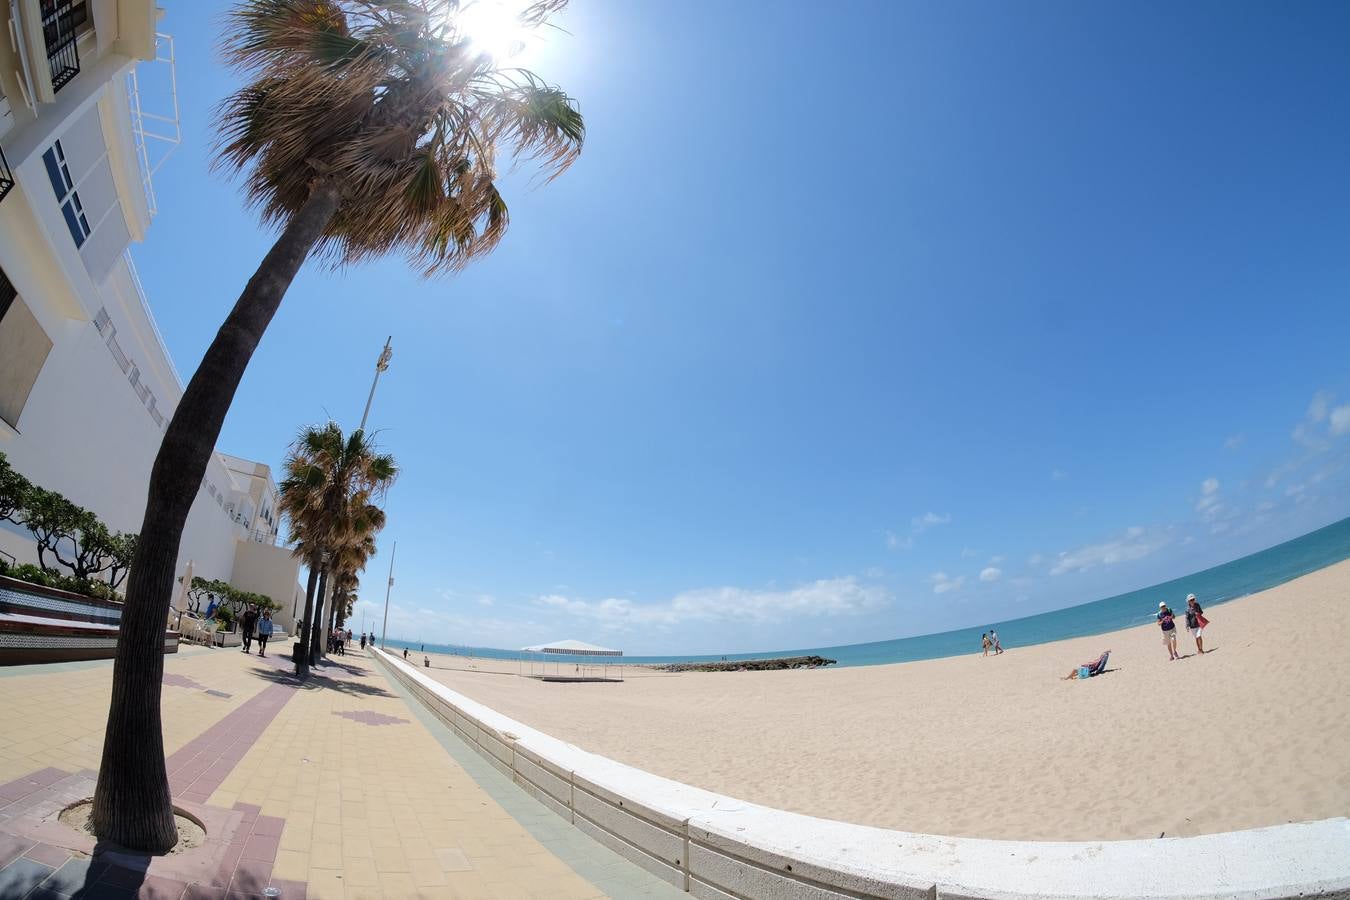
[135,0,1350,653]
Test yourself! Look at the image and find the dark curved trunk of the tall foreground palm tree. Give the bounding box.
[92,182,340,853]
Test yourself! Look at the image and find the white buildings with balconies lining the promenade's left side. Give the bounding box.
[0,0,298,630]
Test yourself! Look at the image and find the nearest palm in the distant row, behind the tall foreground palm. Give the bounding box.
[277,422,398,676]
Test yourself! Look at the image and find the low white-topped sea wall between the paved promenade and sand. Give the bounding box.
[377,650,1350,900]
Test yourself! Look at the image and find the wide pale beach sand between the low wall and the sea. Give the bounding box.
[414,561,1350,839]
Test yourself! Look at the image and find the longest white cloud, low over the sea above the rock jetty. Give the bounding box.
[536,576,890,630]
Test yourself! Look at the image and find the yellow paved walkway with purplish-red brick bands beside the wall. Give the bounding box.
[0,645,682,900]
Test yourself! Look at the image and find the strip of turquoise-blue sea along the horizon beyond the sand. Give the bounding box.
[389,518,1350,665]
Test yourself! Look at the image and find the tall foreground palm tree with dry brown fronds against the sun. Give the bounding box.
[92,0,585,851]
